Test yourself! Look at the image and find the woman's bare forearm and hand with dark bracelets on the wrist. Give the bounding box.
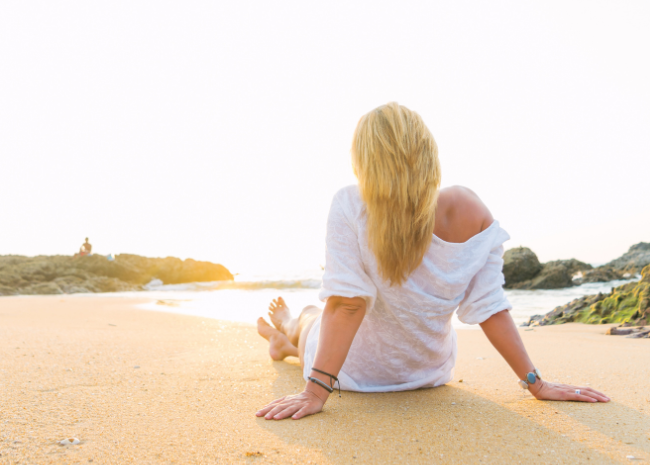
[257,297,366,420]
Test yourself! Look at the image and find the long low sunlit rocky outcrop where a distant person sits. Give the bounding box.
[0,254,233,295]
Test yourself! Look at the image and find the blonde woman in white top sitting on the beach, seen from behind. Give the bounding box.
[257,103,609,420]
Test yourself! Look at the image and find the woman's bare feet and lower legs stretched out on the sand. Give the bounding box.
[257,297,323,365]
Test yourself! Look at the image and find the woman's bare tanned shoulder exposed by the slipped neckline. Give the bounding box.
[434,186,494,242]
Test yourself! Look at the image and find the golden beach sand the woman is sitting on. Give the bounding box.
[0,296,650,464]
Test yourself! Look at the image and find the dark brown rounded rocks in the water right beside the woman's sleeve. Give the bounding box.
[503,247,593,289]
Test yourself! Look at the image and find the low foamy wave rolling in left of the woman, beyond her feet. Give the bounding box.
[143,279,321,291]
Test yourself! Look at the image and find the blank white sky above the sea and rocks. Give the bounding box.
[0,0,650,273]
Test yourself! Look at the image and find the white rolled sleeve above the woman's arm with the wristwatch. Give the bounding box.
[458,245,512,325]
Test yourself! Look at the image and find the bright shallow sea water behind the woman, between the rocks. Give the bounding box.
[93,270,633,328]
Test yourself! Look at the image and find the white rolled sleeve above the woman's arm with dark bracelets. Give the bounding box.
[318,192,377,312]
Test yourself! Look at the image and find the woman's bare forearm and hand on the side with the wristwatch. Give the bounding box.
[481,310,609,402]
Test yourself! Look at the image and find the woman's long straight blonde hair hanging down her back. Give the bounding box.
[352,102,440,285]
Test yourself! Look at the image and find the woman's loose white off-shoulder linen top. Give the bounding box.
[303,185,512,392]
